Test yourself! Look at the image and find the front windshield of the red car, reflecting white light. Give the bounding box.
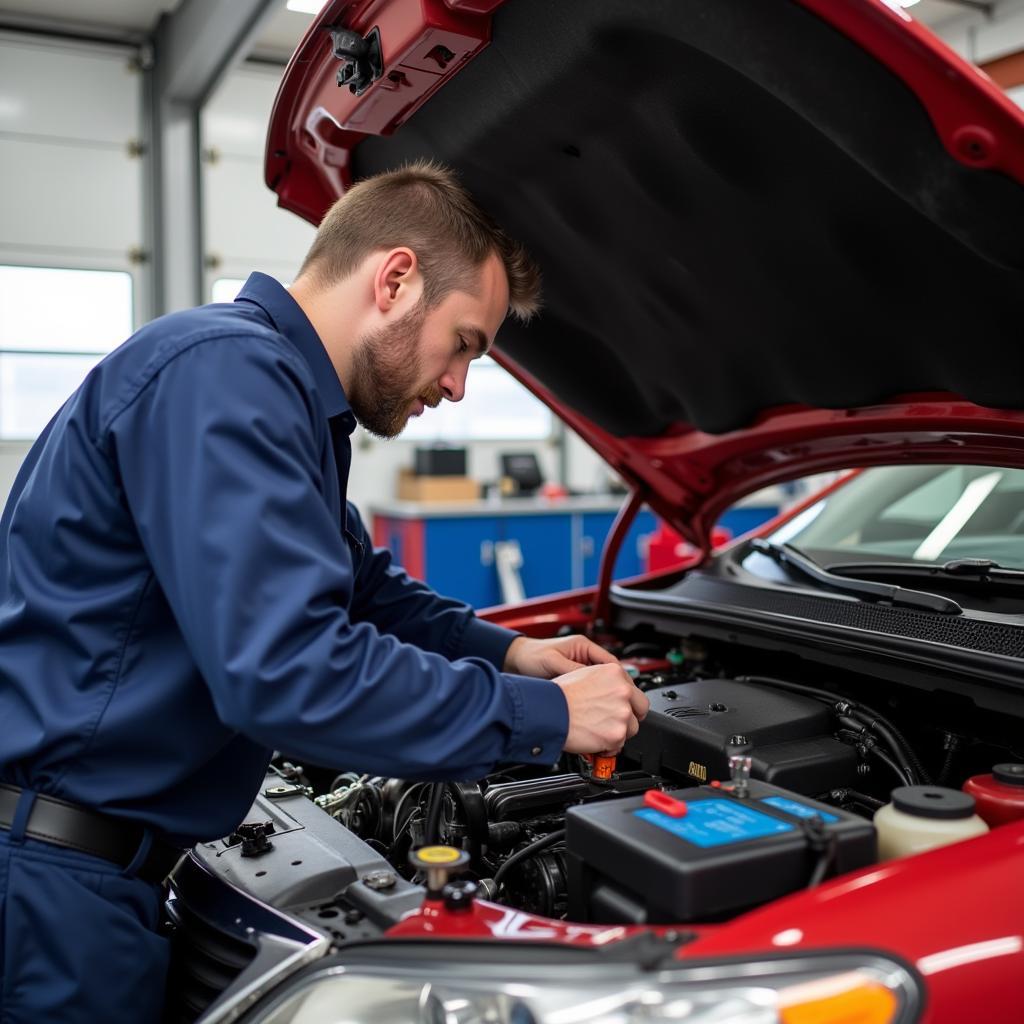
[769,466,1024,568]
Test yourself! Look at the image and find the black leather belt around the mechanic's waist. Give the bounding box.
[0,782,184,883]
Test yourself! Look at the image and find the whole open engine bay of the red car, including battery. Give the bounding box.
[168,630,1024,1021]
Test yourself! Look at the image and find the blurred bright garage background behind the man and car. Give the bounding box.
[0,0,1024,606]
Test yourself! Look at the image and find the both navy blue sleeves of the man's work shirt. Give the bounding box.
[109,334,568,779]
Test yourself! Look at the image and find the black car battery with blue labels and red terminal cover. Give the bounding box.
[565,779,877,924]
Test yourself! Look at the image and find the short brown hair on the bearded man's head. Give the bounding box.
[299,161,541,322]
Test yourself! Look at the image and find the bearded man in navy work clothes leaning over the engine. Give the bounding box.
[0,164,647,1024]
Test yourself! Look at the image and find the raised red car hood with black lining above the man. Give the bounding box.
[266,0,1024,546]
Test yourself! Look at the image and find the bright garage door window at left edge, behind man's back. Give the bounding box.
[0,266,132,440]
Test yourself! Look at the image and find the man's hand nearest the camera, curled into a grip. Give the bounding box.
[554,664,650,754]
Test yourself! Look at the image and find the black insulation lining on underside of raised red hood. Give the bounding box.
[271,0,1024,532]
